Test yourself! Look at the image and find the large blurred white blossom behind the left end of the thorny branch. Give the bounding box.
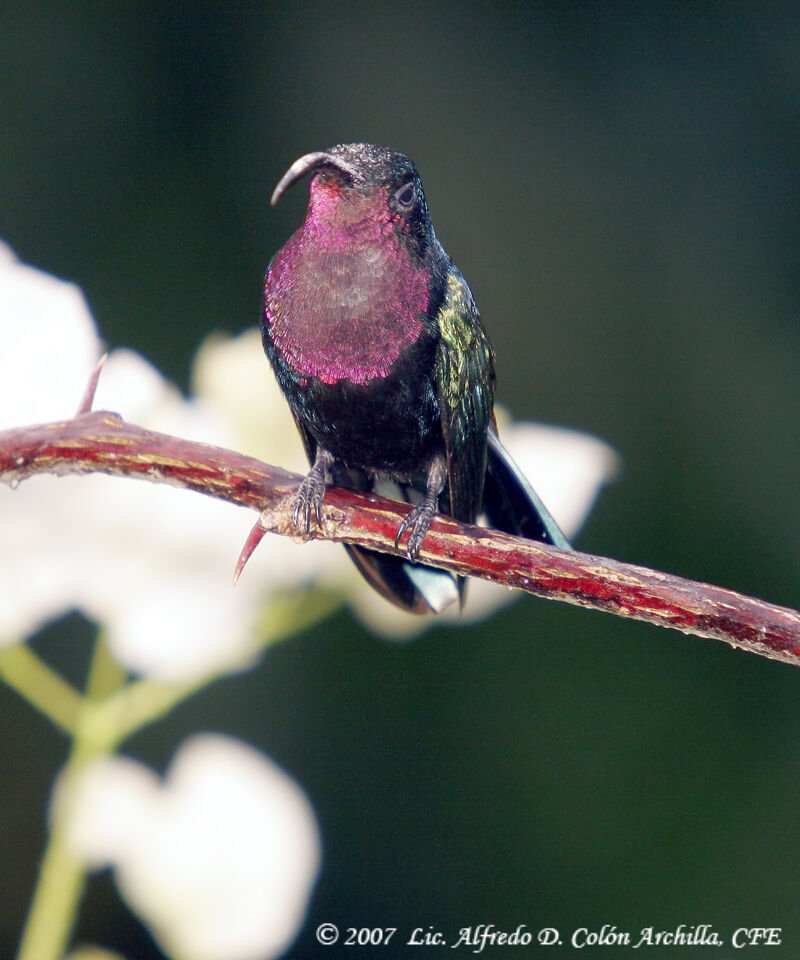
[0,240,332,680]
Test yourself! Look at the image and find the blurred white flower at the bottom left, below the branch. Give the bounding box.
[65,734,320,960]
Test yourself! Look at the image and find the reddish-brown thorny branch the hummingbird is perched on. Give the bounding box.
[0,412,800,665]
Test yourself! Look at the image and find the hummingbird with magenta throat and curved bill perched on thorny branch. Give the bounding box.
[261,143,569,613]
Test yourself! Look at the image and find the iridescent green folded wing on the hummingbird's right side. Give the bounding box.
[437,267,494,523]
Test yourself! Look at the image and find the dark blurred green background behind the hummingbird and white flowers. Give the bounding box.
[0,0,800,960]
